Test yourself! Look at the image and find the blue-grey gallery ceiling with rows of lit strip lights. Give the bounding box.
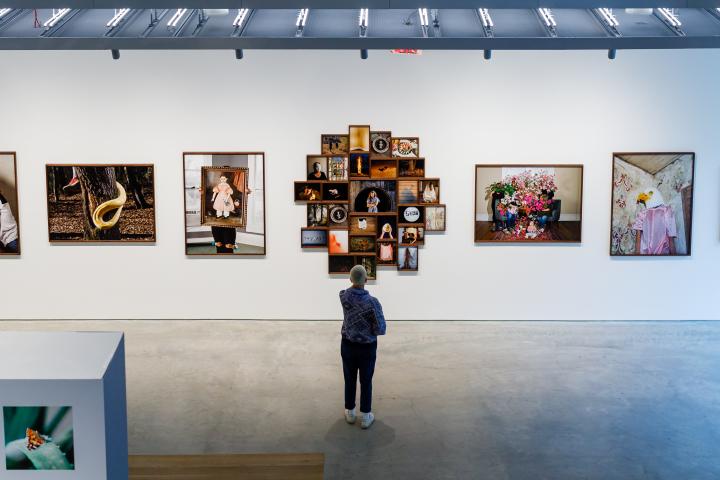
[0,5,720,53]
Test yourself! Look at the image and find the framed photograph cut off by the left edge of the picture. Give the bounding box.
[0,152,20,255]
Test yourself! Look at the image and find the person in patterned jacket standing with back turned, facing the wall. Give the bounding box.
[340,265,386,429]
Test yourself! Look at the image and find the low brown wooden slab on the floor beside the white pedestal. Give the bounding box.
[130,453,325,480]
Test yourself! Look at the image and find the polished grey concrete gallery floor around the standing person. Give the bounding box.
[0,321,720,480]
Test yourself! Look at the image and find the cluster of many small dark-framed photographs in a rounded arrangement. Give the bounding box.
[294,125,446,278]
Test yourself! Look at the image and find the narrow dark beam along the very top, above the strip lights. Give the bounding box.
[0,0,720,9]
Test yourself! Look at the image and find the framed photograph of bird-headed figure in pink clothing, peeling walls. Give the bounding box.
[610,152,695,256]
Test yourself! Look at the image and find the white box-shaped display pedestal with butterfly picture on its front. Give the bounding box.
[0,332,128,480]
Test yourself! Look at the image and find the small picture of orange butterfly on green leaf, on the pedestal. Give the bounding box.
[2,406,75,470]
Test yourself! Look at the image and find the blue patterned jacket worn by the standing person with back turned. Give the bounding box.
[340,288,385,343]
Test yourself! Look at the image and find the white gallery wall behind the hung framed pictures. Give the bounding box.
[0,50,720,320]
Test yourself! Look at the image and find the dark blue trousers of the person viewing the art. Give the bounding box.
[340,338,377,413]
